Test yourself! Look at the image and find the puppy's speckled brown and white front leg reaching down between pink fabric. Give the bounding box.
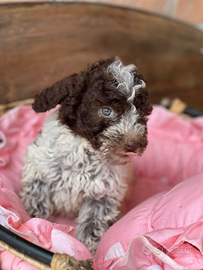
[76,196,119,255]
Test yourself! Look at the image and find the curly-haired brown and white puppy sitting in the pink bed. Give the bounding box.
[21,58,152,254]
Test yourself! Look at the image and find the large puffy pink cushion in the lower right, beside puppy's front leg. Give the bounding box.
[95,173,203,270]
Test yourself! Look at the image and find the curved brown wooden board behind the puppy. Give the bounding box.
[0,3,203,110]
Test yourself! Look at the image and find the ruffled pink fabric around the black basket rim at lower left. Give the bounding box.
[0,183,92,270]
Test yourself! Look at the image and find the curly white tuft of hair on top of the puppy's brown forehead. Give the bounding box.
[107,60,146,103]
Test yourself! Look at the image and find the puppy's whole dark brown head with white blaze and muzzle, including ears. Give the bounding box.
[33,58,152,165]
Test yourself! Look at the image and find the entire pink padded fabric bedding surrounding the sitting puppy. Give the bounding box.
[0,107,203,270]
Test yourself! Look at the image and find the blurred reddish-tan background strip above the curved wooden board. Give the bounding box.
[0,0,203,30]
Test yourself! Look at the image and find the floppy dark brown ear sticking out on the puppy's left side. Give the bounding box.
[32,74,82,112]
